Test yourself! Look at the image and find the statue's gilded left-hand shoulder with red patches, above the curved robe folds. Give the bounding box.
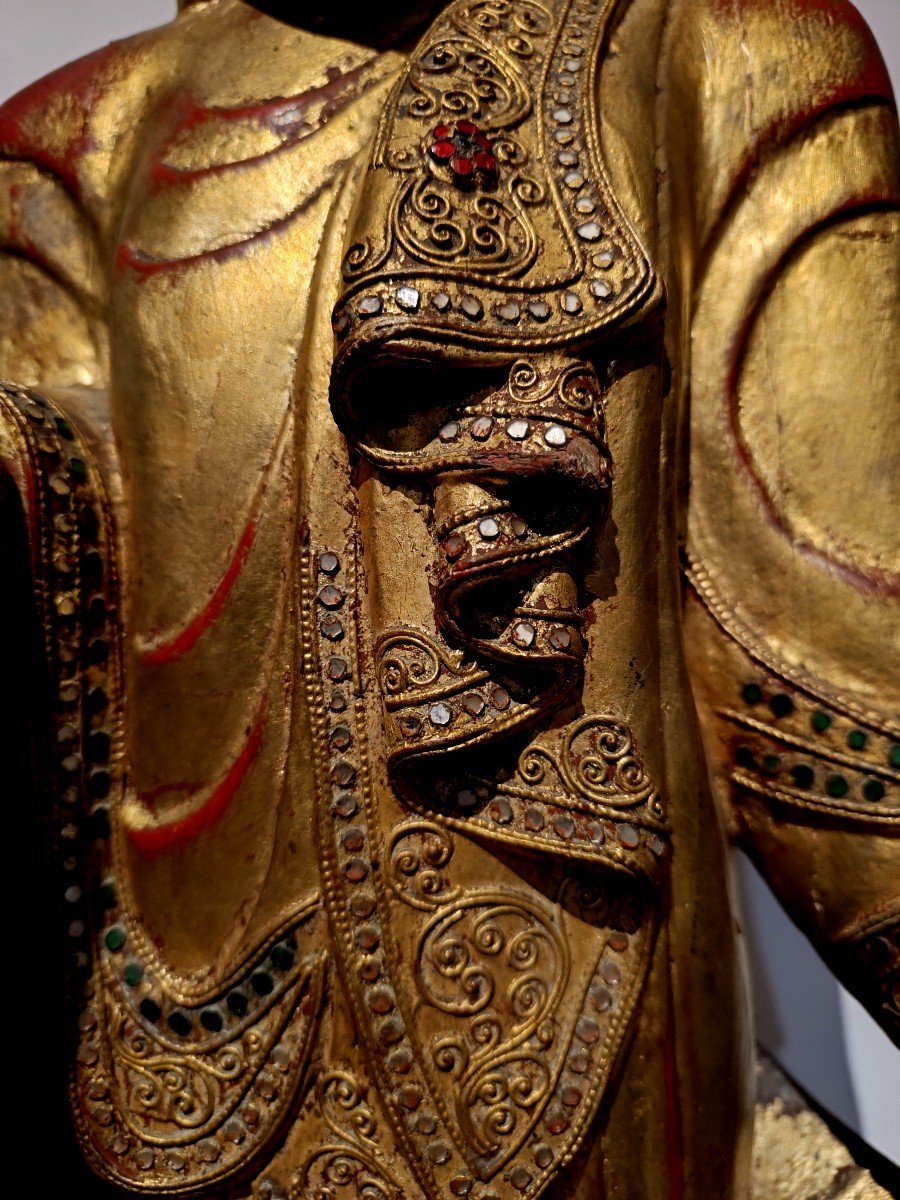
[0,0,396,210]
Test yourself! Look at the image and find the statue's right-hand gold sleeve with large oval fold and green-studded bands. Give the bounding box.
[666,0,900,1037]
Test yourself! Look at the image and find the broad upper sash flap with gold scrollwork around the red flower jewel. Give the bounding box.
[335,0,654,367]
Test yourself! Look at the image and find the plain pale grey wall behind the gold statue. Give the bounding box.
[0,0,900,1163]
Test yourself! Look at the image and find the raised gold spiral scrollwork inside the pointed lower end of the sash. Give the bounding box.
[390,821,569,1160]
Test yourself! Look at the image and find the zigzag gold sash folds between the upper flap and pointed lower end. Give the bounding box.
[361,355,667,878]
